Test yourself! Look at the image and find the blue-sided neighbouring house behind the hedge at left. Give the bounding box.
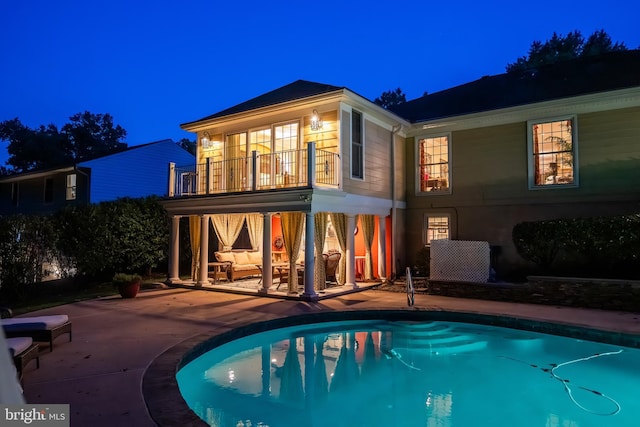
[0,139,194,215]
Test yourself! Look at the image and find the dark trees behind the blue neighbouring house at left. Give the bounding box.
[0,111,127,176]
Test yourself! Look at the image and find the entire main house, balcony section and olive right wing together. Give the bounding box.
[163,51,640,297]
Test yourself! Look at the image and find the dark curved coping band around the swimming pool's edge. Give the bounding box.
[142,309,640,426]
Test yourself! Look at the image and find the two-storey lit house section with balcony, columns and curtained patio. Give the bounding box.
[163,80,408,298]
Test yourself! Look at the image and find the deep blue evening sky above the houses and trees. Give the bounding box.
[0,0,640,164]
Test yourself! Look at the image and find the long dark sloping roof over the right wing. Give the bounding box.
[390,50,640,123]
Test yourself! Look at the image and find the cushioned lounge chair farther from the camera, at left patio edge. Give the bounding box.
[1,314,72,351]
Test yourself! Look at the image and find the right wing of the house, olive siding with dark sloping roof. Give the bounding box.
[393,50,640,277]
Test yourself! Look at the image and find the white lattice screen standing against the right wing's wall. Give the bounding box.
[429,239,491,282]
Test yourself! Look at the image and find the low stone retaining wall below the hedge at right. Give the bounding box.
[404,276,640,313]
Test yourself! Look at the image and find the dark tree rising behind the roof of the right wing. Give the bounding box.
[506,30,627,73]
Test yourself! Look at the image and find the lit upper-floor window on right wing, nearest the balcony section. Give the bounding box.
[418,135,451,192]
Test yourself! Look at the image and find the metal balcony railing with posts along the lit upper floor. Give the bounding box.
[169,143,340,197]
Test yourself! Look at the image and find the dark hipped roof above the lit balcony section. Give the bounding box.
[180,80,346,126]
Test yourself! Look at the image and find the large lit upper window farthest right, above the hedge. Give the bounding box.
[528,117,576,188]
